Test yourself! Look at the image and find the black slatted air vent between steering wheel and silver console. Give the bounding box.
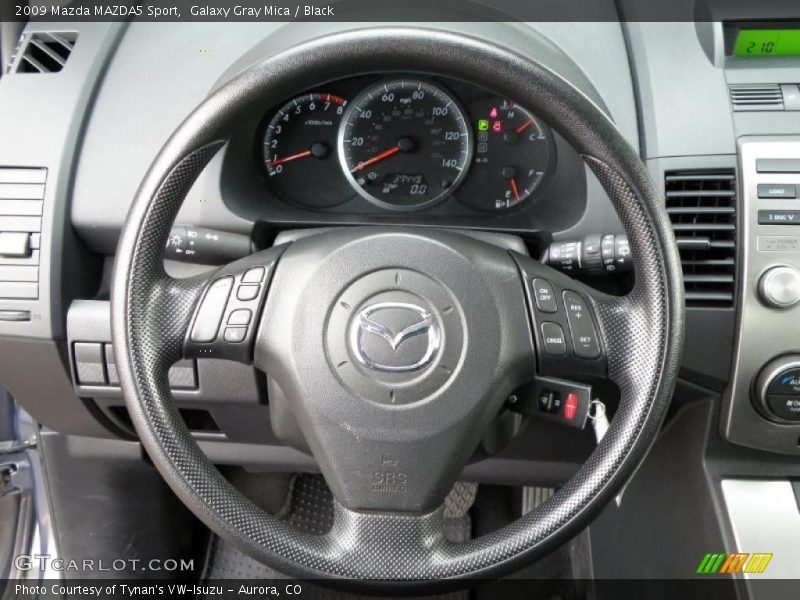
[665,169,736,306]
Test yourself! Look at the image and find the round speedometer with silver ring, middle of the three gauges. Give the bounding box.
[339,79,472,210]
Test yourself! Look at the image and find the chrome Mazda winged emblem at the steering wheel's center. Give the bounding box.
[350,302,441,373]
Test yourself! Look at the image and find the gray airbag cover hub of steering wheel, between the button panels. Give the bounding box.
[255,227,534,512]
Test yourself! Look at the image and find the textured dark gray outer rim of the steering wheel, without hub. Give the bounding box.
[112,27,684,590]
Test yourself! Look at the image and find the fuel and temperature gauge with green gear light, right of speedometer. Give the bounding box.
[458,98,555,211]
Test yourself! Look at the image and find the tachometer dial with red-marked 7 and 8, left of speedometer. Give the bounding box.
[263,94,354,208]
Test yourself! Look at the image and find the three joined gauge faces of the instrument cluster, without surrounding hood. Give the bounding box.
[256,76,556,214]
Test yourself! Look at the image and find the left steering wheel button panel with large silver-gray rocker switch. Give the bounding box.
[183,246,285,365]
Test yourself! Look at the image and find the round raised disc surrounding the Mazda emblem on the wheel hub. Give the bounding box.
[325,268,464,404]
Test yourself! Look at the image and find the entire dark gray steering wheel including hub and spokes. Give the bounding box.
[112,27,684,590]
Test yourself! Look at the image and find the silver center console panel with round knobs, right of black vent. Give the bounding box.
[722,136,800,455]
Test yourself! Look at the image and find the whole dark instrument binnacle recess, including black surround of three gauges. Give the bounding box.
[221,73,586,230]
